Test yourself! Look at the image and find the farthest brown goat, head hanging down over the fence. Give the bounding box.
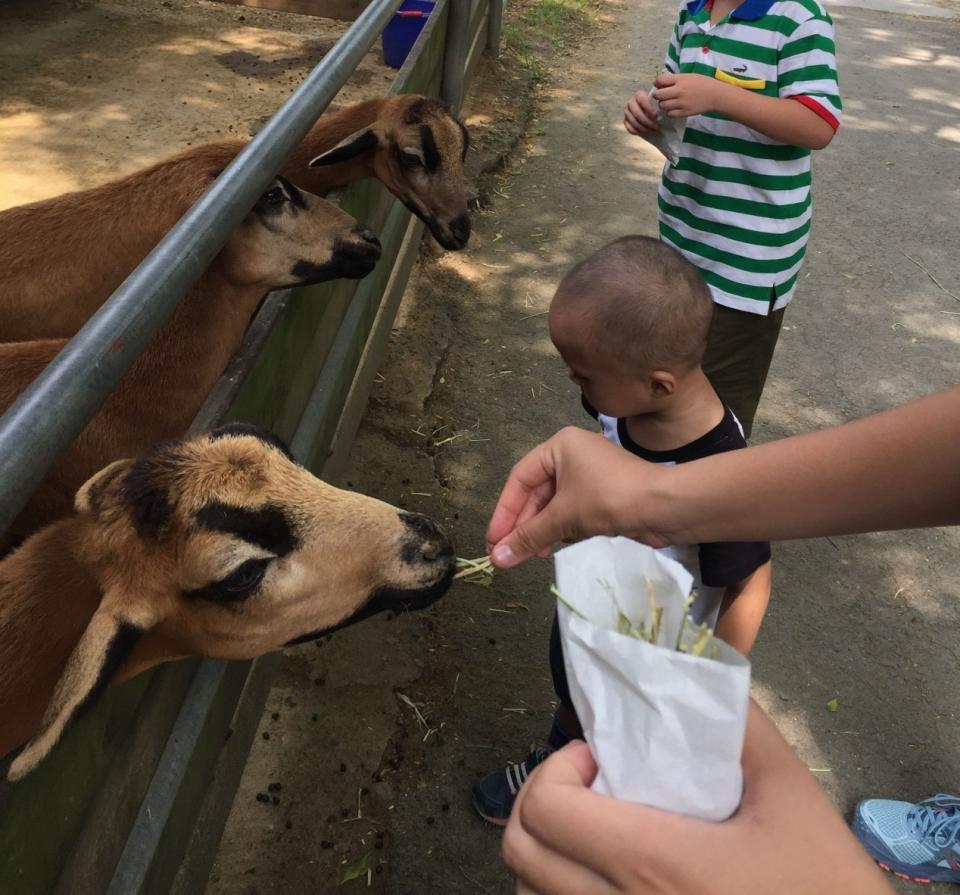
[0,96,470,342]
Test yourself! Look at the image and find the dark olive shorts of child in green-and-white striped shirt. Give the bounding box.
[703,304,785,438]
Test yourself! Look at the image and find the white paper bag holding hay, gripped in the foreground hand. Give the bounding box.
[556,538,750,820]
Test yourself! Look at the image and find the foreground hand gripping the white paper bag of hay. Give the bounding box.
[503,703,891,895]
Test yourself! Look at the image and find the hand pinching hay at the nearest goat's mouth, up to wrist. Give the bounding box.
[487,427,669,568]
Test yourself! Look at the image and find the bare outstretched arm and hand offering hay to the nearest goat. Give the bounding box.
[487,387,960,568]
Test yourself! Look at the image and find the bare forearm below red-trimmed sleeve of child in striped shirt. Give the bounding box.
[652,72,835,149]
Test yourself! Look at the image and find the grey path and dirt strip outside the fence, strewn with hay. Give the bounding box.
[208,0,960,895]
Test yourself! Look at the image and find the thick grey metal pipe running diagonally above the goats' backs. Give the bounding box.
[0,0,402,531]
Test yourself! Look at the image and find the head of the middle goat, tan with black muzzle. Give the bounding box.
[220,177,380,290]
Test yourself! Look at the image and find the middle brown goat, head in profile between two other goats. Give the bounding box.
[0,172,380,539]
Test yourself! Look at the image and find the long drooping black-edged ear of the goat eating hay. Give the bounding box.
[7,594,148,781]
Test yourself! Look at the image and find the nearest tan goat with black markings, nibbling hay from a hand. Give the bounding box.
[0,424,454,780]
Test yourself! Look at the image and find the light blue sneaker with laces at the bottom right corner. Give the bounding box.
[853,793,960,883]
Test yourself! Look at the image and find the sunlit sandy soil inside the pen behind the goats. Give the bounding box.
[0,0,396,209]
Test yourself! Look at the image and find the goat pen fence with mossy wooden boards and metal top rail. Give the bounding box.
[0,0,502,895]
